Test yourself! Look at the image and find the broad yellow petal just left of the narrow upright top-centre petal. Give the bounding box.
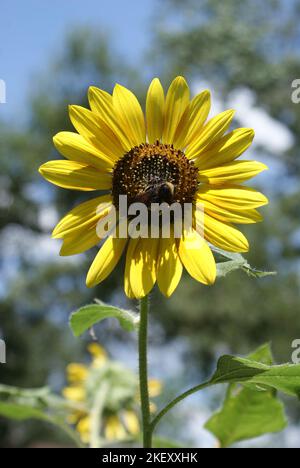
[113,84,146,147]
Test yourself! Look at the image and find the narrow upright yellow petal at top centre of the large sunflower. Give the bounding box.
[146,78,165,144]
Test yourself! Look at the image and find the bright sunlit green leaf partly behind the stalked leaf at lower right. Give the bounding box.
[205,345,287,448]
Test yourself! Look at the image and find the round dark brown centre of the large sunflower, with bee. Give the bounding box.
[112,142,198,207]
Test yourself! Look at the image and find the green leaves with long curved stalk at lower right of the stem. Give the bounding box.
[152,344,300,448]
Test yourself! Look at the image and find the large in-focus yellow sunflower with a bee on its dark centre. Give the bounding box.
[40,77,267,298]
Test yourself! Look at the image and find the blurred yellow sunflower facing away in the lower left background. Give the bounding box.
[62,343,162,444]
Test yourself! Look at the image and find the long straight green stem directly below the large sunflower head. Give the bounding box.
[139,296,152,448]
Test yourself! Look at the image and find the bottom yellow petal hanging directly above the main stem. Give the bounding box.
[125,238,159,299]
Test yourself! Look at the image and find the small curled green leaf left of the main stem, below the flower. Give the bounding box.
[70,301,139,337]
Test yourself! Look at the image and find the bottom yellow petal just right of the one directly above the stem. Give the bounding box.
[157,237,183,297]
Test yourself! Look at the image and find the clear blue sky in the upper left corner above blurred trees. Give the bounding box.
[0,0,156,118]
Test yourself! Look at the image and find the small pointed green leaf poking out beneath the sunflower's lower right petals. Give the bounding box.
[212,247,276,278]
